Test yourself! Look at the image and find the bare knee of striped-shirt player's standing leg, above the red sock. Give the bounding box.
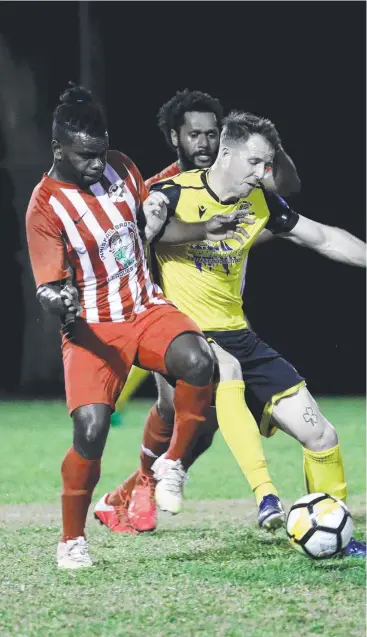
[73,405,111,460]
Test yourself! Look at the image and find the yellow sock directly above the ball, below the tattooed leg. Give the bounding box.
[303,444,347,502]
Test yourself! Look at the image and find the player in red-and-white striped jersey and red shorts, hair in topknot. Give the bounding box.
[26,85,247,568]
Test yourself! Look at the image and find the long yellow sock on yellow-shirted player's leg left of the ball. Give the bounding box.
[215,380,278,504]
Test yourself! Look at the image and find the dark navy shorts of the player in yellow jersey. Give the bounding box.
[204,329,305,437]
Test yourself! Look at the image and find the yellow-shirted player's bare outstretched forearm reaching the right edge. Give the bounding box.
[278,215,366,268]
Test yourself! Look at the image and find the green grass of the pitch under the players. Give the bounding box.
[0,398,365,637]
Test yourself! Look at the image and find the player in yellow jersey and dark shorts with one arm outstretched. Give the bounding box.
[100,113,366,556]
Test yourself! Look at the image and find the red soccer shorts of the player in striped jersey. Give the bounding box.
[62,305,201,413]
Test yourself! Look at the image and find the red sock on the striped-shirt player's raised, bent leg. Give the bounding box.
[166,380,213,460]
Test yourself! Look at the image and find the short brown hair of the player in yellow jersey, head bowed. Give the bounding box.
[222,111,281,151]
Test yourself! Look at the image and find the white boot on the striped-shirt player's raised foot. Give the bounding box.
[152,454,186,514]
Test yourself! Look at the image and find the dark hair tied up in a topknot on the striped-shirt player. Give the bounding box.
[52,82,107,141]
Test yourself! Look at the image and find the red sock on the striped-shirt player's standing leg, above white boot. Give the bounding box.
[61,447,101,542]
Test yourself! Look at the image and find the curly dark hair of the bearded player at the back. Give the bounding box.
[158,88,223,147]
